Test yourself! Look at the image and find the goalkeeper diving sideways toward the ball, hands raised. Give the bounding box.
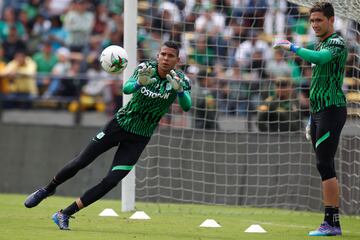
[24,41,191,230]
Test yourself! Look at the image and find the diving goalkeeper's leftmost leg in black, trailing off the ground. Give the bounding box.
[24,119,119,208]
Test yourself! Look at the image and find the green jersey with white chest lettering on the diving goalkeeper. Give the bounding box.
[115,61,191,137]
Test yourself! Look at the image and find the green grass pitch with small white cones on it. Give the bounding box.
[0,194,360,240]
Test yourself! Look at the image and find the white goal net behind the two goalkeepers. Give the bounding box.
[136,0,360,214]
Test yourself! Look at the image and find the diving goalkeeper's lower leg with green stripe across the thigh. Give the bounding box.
[53,133,150,230]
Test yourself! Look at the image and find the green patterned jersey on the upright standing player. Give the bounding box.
[310,33,347,112]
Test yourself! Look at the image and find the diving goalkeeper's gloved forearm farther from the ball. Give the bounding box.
[166,70,192,112]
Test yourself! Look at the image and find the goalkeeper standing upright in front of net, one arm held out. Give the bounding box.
[274,2,347,236]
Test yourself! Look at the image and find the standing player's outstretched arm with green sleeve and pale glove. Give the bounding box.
[273,40,333,65]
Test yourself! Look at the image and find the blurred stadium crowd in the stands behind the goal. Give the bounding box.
[0,0,360,129]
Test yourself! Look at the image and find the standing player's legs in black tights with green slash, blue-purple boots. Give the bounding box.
[310,108,346,236]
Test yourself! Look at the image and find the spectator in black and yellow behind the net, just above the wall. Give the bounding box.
[258,78,301,132]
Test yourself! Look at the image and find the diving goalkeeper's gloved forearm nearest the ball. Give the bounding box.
[123,63,156,94]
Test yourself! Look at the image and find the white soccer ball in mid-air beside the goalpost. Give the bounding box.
[99,45,128,73]
